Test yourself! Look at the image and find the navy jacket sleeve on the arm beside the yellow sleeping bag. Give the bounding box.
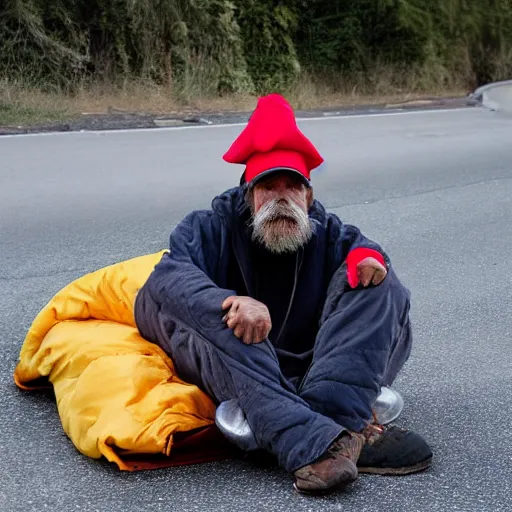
[135,212,236,342]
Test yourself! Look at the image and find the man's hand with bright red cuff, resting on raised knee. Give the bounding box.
[347,247,388,288]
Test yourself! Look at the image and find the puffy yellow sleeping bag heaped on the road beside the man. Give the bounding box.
[14,251,222,470]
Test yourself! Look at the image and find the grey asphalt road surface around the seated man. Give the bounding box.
[0,109,512,512]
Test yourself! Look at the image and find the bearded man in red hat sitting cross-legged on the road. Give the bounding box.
[135,94,432,493]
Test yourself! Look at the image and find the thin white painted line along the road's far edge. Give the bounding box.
[0,107,483,141]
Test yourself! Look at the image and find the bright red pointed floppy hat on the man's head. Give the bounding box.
[223,94,324,184]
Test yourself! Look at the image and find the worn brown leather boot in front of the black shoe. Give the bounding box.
[294,432,364,494]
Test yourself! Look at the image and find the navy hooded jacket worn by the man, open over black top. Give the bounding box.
[135,187,389,380]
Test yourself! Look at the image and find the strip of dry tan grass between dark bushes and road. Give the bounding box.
[0,73,468,126]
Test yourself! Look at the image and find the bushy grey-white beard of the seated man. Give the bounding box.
[252,198,313,254]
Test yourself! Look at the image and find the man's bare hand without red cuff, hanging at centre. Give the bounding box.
[222,295,272,345]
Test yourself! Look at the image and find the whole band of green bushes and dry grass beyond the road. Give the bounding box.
[0,0,512,125]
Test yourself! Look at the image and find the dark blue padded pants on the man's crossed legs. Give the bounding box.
[159,267,412,472]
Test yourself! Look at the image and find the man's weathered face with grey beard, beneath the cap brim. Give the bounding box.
[249,172,313,254]
